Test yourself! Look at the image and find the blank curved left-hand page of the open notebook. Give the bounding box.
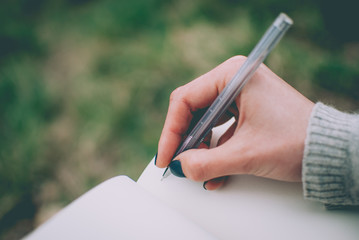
[26,176,217,240]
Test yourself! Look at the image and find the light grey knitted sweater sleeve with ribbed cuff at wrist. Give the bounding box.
[302,103,359,205]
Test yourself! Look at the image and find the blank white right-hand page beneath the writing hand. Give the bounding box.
[137,120,359,240]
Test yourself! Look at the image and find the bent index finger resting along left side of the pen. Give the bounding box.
[156,56,245,167]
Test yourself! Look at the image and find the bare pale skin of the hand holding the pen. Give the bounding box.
[156,56,314,190]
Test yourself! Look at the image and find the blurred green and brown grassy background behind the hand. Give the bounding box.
[0,0,359,239]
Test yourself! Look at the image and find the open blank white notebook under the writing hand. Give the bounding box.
[25,121,359,240]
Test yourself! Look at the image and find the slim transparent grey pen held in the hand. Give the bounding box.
[162,13,293,180]
